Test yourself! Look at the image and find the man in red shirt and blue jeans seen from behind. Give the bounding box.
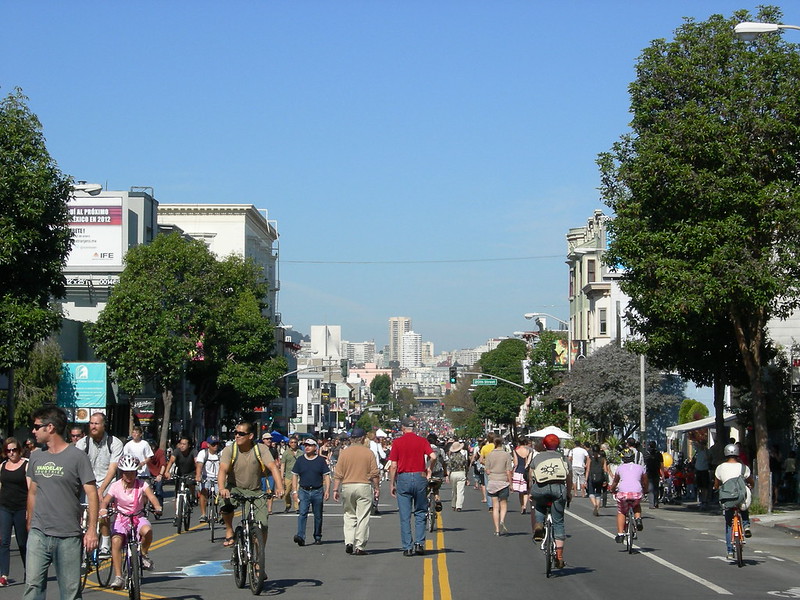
[389,418,436,556]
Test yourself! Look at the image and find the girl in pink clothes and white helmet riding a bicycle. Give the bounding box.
[100,454,162,590]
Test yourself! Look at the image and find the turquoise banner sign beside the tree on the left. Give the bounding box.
[57,362,108,423]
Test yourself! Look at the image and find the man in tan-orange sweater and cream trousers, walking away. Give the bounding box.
[333,427,380,556]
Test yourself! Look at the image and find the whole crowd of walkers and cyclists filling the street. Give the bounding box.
[0,406,796,599]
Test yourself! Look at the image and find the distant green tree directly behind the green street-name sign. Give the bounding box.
[472,339,528,432]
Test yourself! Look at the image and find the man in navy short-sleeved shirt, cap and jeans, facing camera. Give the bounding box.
[292,438,331,546]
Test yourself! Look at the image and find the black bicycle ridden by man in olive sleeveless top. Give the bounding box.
[231,492,275,596]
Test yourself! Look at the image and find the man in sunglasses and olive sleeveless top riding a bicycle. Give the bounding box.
[218,421,284,547]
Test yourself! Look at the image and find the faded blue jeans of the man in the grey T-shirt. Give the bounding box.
[22,529,83,600]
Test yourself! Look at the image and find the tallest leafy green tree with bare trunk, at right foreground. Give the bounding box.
[599,7,800,505]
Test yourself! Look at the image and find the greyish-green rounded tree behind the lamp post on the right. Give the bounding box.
[554,344,683,439]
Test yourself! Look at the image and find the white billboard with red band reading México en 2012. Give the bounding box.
[67,196,123,268]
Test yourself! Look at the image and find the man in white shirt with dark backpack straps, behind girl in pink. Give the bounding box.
[75,412,123,559]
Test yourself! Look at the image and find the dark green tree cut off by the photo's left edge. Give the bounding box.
[0,89,72,430]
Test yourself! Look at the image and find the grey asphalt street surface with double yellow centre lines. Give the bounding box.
[3,483,800,600]
